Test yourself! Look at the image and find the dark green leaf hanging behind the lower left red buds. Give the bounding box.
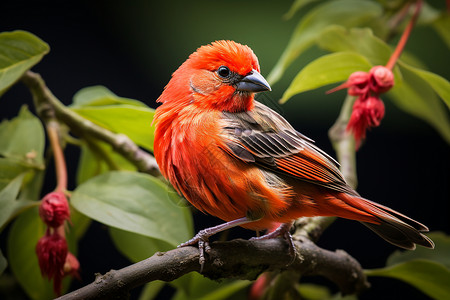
[8,207,71,300]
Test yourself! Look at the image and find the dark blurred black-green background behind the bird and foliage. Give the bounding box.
[0,0,450,299]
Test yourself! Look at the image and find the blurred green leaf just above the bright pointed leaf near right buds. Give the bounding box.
[318,25,391,65]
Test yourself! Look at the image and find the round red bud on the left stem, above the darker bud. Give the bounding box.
[39,192,70,228]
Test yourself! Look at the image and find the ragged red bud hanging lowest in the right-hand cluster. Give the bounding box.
[347,96,384,148]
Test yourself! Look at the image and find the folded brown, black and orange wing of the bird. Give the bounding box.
[221,101,357,195]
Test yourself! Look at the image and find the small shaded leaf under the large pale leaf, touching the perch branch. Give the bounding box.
[109,227,174,262]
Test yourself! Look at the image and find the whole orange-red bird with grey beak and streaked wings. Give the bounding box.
[154,41,434,265]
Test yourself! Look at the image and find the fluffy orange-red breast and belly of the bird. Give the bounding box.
[155,111,291,229]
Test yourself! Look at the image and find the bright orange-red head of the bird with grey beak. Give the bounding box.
[158,41,271,112]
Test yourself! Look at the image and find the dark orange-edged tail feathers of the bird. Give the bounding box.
[341,194,434,250]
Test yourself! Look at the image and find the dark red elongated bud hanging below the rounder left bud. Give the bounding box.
[36,230,68,295]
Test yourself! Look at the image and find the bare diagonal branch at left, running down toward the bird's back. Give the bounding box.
[22,71,160,176]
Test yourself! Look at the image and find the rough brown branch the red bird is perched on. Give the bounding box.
[58,238,369,300]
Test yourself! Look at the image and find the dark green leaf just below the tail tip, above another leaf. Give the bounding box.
[386,232,450,270]
